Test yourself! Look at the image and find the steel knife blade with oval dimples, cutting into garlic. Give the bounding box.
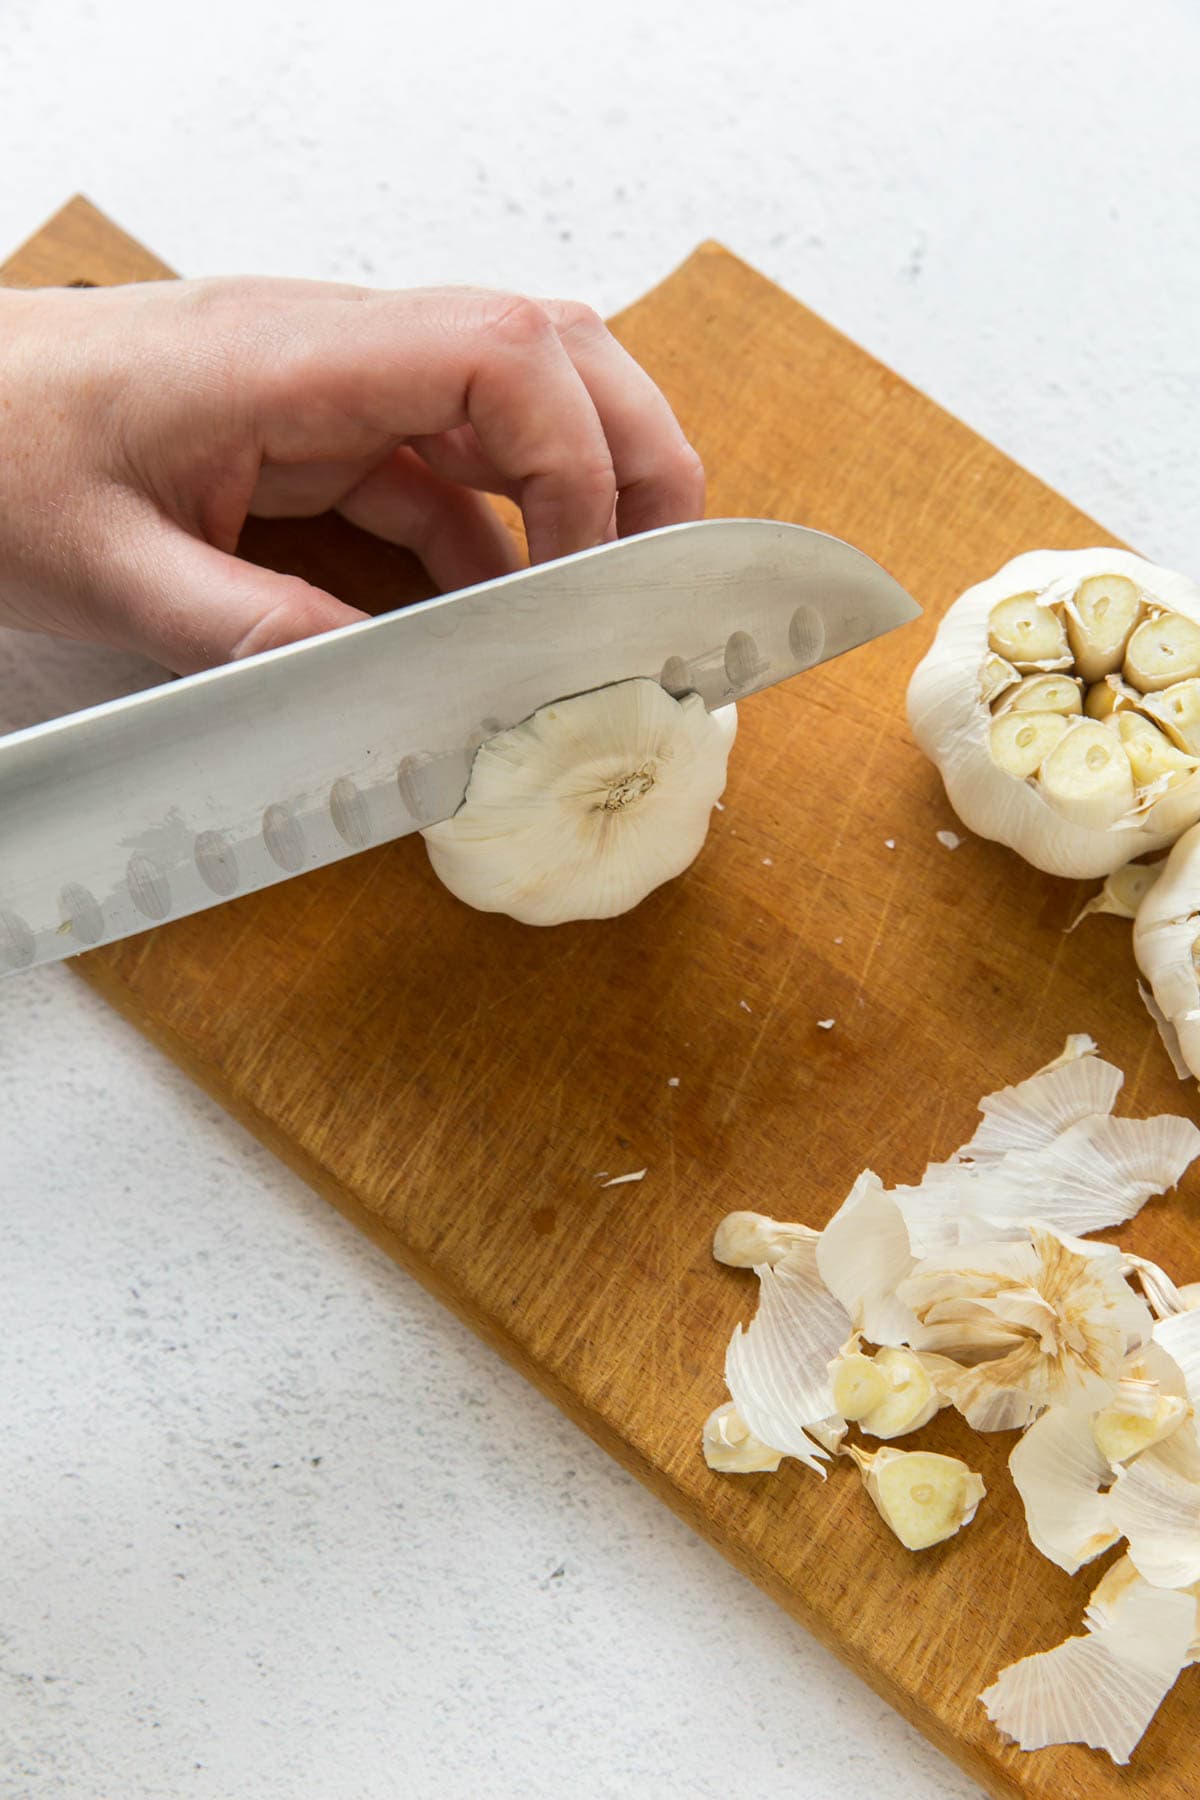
[0,518,919,974]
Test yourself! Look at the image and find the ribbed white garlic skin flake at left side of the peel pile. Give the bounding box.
[725,1262,851,1476]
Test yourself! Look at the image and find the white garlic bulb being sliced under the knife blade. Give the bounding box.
[421,677,738,925]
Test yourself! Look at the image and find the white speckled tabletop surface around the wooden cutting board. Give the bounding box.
[0,0,1200,1800]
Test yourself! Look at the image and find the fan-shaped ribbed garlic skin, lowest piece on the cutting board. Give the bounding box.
[979,1584,1195,1764]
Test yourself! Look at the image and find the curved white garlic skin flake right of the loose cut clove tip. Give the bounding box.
[1007,1406,1121,1575]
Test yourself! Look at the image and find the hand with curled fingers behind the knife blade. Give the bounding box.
[0,279,703,673]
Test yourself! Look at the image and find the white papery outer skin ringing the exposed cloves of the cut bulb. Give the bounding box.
[909,547,1200,877]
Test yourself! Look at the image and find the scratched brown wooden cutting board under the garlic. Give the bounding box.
[0,200,1200,1800]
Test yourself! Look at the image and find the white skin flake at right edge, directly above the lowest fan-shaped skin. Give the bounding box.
[1112,1424,1200,1588]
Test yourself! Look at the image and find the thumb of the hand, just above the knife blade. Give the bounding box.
[97,524,367,675]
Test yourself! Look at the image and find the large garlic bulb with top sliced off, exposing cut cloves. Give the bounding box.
[909,547,1200,877]
